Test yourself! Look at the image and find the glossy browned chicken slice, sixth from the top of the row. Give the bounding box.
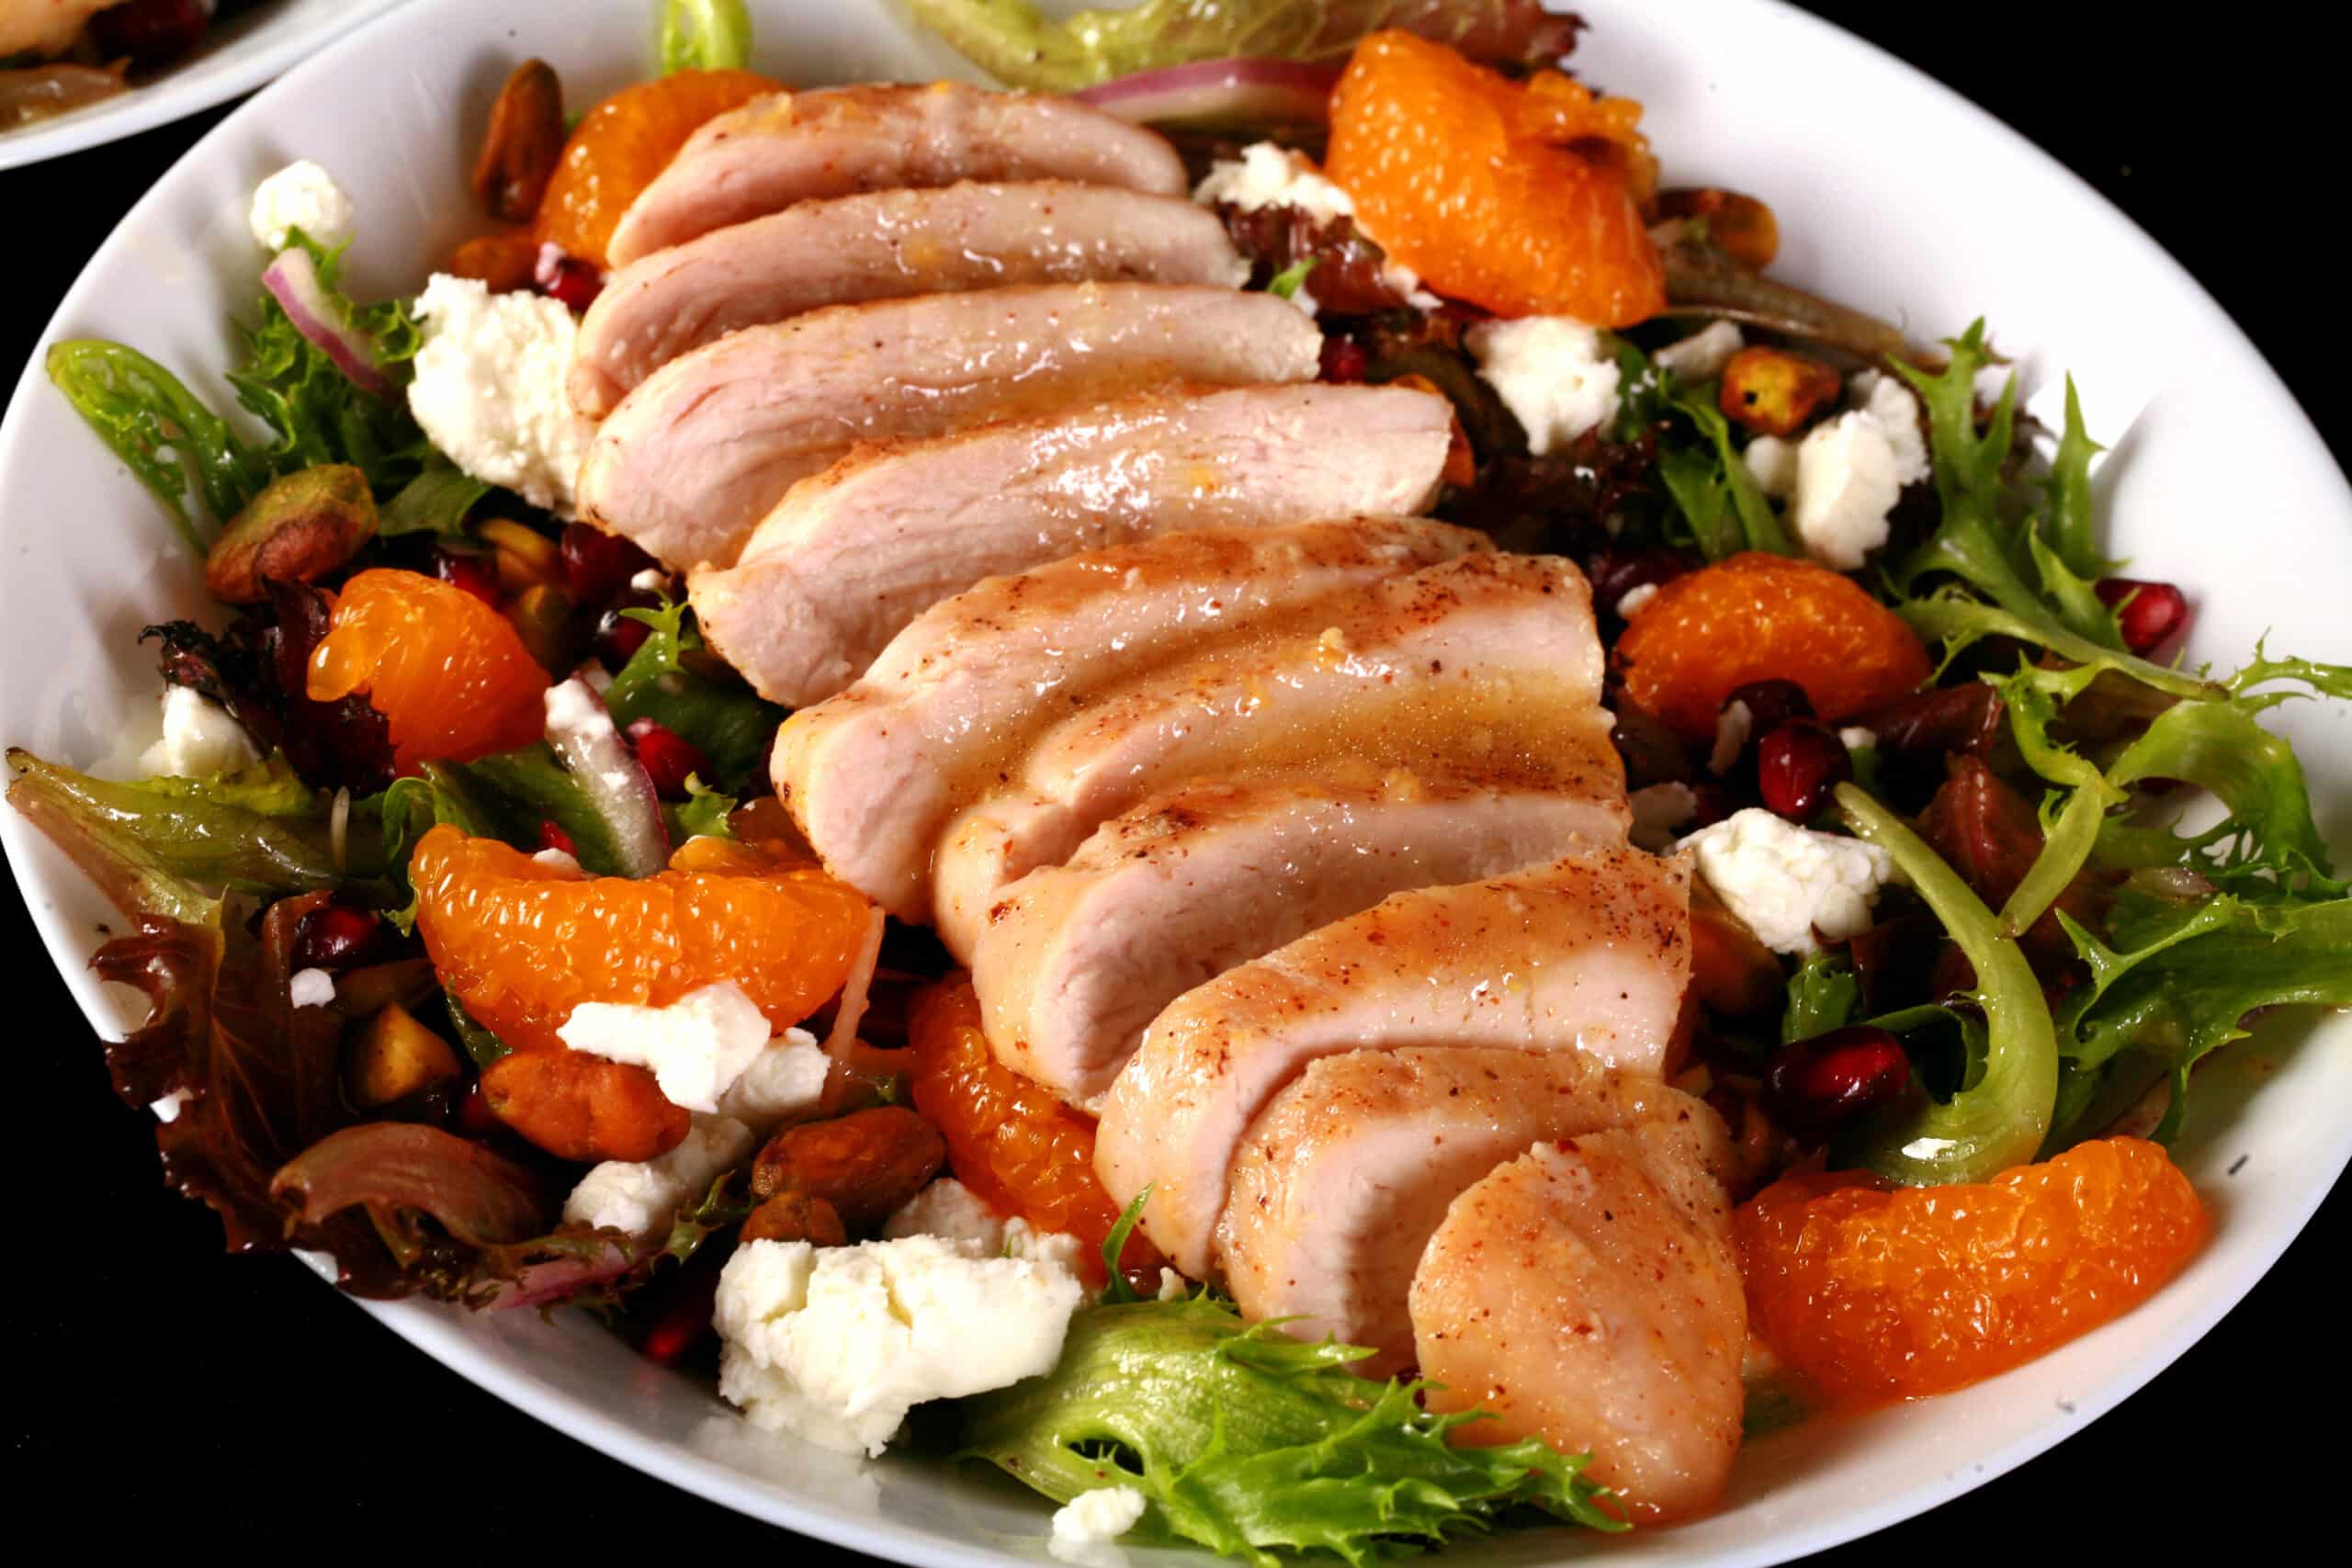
[932,555,1625,964]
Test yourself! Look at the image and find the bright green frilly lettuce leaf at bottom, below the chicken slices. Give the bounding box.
[959,1295,1623,1568]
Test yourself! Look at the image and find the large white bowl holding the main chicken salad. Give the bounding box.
[0,0,2352,1563]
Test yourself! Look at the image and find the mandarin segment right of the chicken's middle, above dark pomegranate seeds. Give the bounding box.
[1611,550,1931,740]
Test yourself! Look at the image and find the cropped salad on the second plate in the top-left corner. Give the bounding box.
[0,0,267,130]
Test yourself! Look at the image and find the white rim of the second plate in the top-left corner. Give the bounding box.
[0,0,402,169]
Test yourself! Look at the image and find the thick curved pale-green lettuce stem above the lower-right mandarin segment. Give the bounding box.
[1837,783,2058,1187]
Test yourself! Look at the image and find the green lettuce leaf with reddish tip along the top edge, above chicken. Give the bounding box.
[908,0,1580,92]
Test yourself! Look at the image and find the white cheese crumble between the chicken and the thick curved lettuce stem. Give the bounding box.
[1681,807,1895,952]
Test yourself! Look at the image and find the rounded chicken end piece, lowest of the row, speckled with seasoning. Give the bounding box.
[1411,1122,1747,1523]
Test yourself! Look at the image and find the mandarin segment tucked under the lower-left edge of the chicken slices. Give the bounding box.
[908,974,1162,1281]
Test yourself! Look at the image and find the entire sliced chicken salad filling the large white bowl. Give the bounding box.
[9,5,2352,1561]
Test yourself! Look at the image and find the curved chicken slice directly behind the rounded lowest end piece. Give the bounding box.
[1216,1046,1731,1378]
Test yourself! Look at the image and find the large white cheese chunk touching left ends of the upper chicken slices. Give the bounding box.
[409,273,595,517]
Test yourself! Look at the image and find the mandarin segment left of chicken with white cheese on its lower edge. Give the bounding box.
[409,828,870,1051]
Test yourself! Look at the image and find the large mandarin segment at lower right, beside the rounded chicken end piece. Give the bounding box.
[1736,1138,2209,1405]
